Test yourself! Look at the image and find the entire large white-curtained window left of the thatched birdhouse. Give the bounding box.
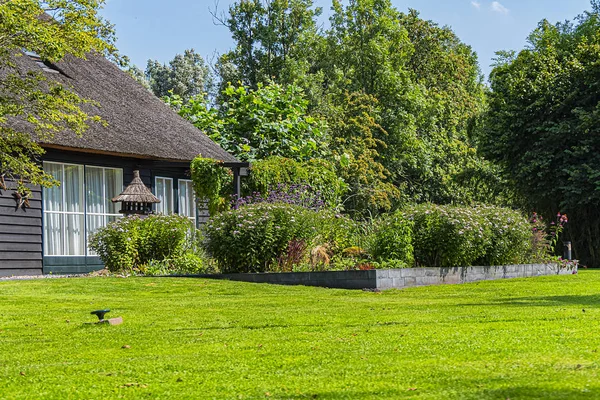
[43,162,123,256]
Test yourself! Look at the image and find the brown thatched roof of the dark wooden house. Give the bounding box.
[5,54,238,163]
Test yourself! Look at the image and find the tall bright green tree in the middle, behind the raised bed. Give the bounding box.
[322,0,484,203]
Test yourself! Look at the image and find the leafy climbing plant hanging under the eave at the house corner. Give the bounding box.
[191,156,231,214]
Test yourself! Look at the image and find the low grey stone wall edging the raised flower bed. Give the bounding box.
[194,264,577,290]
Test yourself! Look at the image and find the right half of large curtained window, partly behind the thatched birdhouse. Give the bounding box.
[85,166,123,248]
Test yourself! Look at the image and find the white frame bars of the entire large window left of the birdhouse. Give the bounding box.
[42,161,123,257]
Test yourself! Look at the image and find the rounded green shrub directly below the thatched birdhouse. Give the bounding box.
[89,215,196,272]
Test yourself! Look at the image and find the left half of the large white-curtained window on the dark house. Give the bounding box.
[44,162,85,256]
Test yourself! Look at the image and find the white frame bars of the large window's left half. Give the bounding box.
[42,161,87,257]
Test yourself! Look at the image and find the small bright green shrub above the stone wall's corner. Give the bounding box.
[368,211,414,266]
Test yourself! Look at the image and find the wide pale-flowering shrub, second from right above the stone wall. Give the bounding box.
[404,204,491,267]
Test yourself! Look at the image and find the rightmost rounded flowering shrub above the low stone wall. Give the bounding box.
[475,206,533,265]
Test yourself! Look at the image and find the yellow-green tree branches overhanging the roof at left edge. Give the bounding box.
[0,0,119,196]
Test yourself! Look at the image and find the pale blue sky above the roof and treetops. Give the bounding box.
[102,0,590,76]
